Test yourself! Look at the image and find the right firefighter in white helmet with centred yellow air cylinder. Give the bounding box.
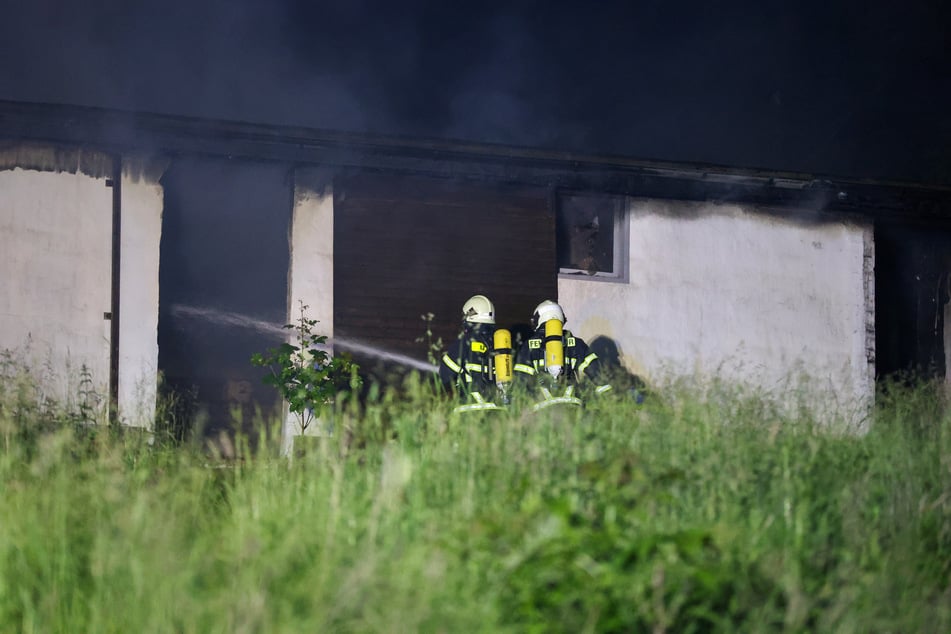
[514,300,611,410]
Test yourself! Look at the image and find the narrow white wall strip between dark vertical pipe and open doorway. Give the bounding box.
[119,162,164,427]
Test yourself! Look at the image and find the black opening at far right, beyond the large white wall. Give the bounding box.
[875,223,951,378]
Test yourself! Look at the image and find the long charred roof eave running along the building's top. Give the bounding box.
[0,100,951,222]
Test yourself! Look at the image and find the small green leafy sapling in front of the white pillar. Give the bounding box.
[251,302,362,434]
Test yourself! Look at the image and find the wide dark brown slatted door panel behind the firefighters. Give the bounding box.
[334,173,558,378]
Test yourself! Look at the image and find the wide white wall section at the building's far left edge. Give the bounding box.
[0,168,112,404]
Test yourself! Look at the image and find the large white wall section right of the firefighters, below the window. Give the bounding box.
[558,199,874,421]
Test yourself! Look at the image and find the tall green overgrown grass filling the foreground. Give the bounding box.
[0,372,951,634]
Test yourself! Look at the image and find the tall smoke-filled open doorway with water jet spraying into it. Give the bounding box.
[158,158,292,442]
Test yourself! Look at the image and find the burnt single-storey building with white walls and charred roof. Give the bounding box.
[0,102,951,440]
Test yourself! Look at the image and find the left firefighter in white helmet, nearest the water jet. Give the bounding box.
[439,295,512,412]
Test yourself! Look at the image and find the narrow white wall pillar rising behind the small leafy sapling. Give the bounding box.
[282,170,334,453]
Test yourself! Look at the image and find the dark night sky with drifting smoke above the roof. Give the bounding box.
[0,0,951,183]
